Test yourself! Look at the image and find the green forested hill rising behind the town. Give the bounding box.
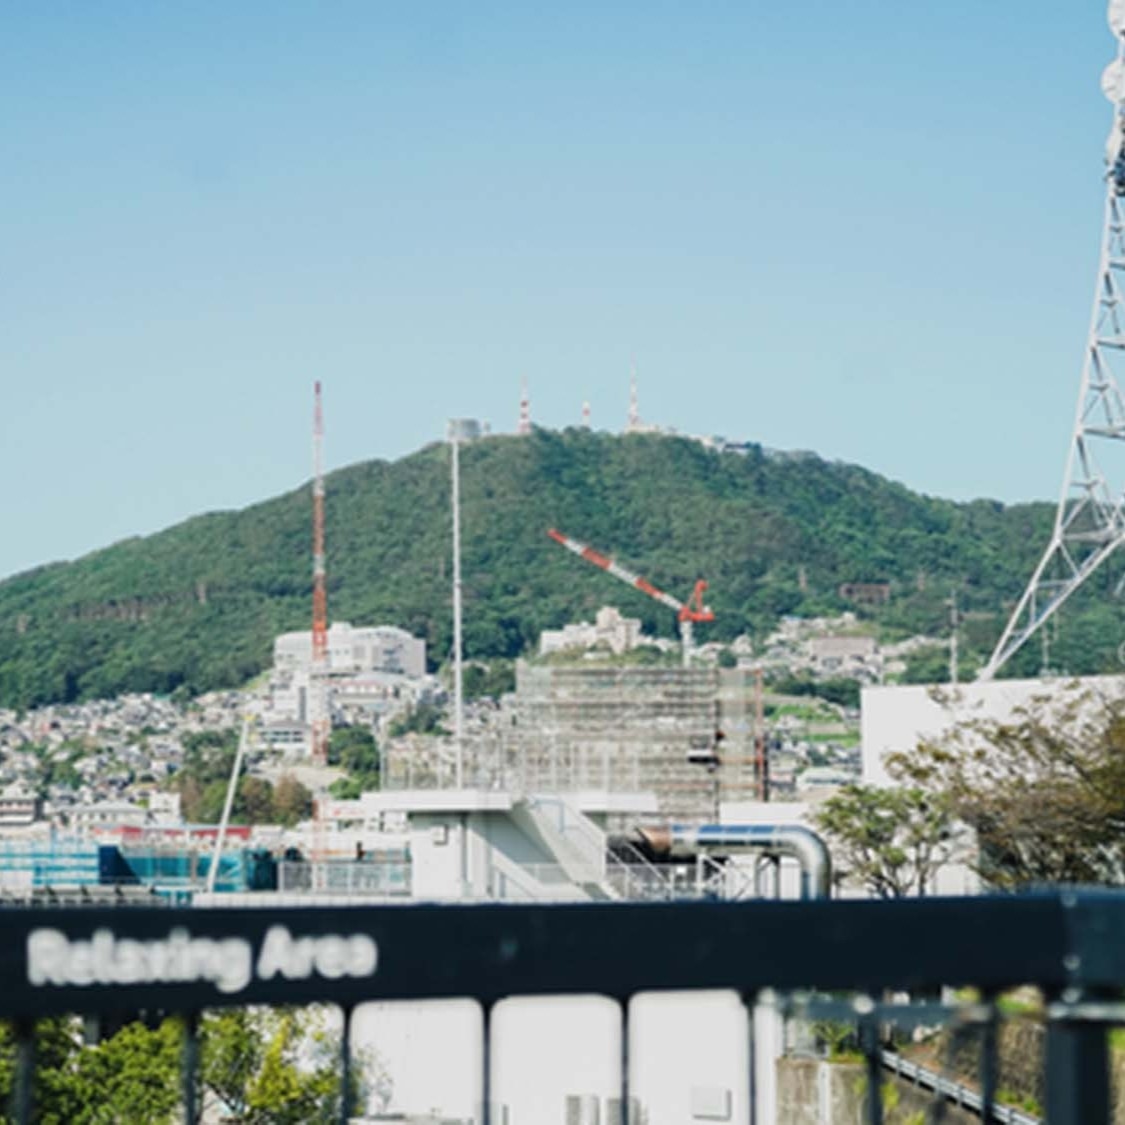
[0,431,1125,707]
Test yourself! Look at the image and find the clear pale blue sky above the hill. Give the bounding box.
[0,0,1114,574]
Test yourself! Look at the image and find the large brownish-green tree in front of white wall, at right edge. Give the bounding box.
[889,689,1125,888]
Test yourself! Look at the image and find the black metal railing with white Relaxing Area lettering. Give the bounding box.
[0,890,1125,1125]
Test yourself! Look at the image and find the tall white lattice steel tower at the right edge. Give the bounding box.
[978,0,1125,680]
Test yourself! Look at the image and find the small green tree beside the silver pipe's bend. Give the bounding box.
[815,785,953,899]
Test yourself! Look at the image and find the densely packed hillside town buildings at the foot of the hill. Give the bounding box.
[0,606,954,835]
